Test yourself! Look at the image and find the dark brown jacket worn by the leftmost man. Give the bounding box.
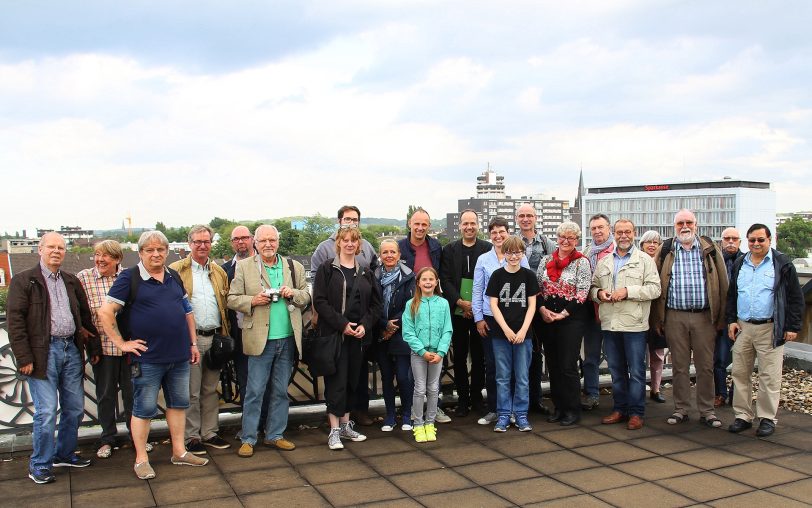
[7,263,102,379]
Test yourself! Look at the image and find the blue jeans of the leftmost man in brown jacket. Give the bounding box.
[28,337,85,471]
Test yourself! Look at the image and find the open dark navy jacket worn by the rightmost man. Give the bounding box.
[725,249,804,347]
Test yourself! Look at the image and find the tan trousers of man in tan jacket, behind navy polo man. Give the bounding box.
[186,336,220,442]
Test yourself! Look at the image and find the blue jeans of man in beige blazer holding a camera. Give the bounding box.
[240,337,296,446]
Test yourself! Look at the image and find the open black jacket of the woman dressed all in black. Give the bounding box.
[313,257,381,344]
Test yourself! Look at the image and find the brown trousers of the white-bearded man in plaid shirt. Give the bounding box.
[664,309,718,417]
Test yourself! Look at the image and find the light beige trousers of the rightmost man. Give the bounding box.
[731,321,784,422]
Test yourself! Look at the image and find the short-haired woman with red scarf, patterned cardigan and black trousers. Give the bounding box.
[536,222,592,426]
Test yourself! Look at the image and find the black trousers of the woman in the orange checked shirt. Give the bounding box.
[92,355,133,446]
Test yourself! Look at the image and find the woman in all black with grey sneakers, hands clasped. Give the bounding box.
[313,227,381,450]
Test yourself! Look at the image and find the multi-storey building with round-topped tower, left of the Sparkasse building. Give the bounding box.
[446,167,570,239]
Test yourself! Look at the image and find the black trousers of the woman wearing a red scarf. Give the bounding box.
[542,317,585,415]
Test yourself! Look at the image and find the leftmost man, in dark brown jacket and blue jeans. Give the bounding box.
[7,233,101,483]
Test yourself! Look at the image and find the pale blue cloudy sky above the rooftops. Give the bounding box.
[0,0,812,235]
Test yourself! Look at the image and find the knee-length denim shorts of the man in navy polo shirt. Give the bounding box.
[132,361,189,420]
